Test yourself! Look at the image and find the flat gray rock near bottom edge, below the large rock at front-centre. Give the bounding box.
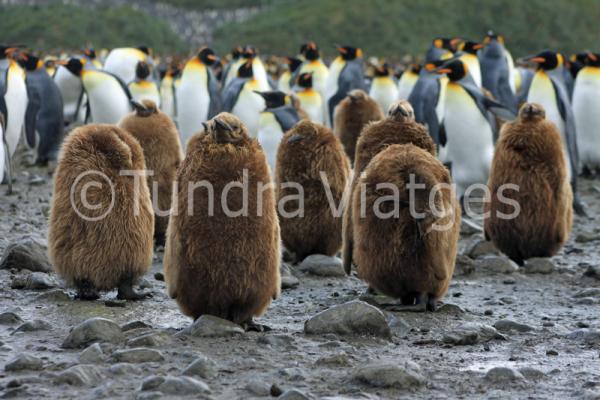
[354,360,426,389]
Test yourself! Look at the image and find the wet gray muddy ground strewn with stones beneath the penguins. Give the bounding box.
[0,157,600,399]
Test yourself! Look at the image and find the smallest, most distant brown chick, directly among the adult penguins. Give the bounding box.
[333,89,384,163]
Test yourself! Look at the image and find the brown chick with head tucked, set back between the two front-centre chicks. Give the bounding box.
[276,120,350,261]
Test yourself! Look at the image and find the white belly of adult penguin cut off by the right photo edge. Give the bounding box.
[573,67,600,168]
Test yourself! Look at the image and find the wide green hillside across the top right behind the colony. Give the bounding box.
[214,0,600,58]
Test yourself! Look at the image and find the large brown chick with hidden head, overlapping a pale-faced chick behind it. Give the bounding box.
[352,144,461,311]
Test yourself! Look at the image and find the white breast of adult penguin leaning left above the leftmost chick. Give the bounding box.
[83,71,131,124]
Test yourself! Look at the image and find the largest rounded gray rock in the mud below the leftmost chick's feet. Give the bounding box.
[62,318,125,349]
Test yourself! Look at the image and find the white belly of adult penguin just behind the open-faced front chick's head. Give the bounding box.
[176,74,210,148]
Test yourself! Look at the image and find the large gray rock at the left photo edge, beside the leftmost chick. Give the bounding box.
[0,235,52,272]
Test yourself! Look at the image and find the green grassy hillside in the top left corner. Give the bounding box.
[0,4,187,51]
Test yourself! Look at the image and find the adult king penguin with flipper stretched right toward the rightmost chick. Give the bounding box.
[437,59,515,197]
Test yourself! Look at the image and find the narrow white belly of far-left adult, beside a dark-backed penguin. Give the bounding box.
[4,67,27,155]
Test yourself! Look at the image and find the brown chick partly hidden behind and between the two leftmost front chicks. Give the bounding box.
[119,100,183,245]
